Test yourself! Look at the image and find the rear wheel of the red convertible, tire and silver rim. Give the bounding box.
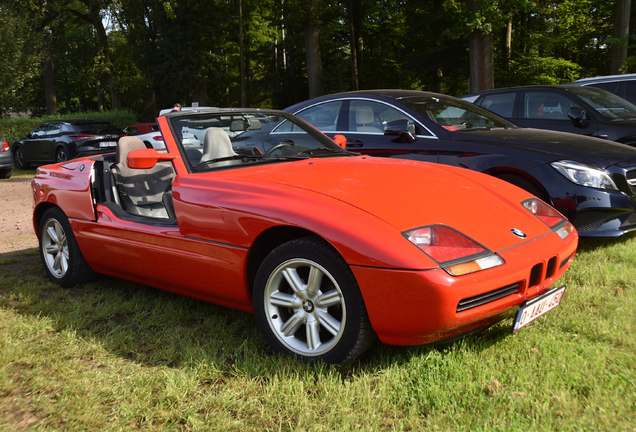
[39,207,96,287]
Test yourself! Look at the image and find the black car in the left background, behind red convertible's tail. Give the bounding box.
[11,119,124,169]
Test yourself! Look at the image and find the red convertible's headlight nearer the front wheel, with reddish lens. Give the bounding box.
[402,225,504,276]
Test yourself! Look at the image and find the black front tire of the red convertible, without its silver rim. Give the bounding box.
[253,237,370,364]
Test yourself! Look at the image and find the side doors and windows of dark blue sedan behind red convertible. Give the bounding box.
[296,98,439,162]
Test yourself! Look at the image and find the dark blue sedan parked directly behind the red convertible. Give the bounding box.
[286,90,636,237]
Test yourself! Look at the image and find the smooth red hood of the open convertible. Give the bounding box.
[222,156,550,251]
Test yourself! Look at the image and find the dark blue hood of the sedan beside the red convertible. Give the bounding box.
[451,128,636,169]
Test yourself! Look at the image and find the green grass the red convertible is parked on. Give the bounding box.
[0,235,636,431]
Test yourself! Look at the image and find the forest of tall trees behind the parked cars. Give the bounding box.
[0,0,636,121]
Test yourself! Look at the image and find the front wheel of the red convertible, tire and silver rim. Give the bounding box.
[254,237,376,364]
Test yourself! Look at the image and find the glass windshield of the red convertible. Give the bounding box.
[168,110,349,171]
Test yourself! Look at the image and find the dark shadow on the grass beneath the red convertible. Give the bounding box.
[0,249,511,379]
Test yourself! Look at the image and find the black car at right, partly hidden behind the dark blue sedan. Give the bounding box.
[462,85,636,146]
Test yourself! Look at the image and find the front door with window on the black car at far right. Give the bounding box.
[513,90,598,135]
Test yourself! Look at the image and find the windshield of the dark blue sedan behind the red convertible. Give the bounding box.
[399,95,515,132]
